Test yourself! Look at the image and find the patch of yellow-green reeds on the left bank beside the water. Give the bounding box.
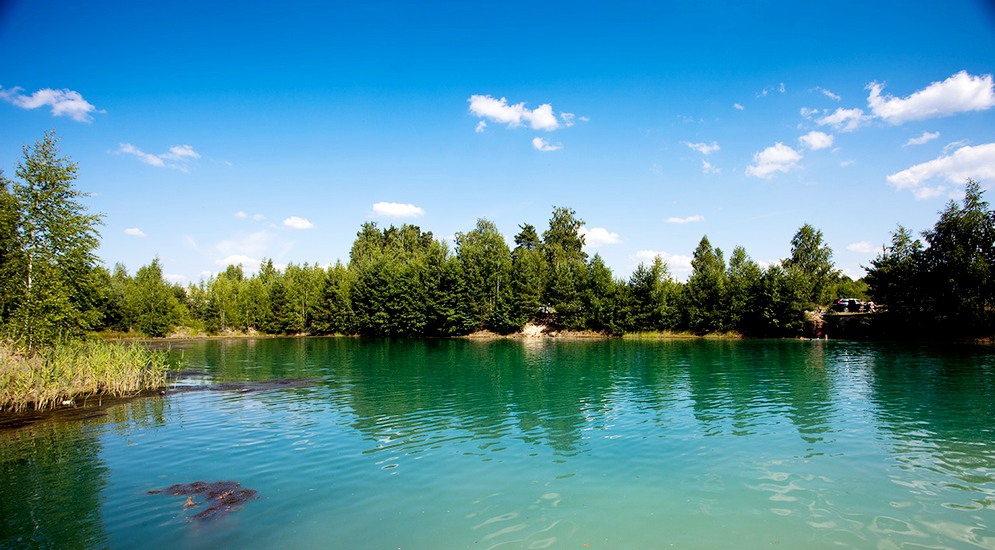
[0,341,168,411]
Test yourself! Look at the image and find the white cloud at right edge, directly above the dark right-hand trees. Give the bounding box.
[888,143,995,199]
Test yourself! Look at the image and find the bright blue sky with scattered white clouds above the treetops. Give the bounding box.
[0,0,995,284]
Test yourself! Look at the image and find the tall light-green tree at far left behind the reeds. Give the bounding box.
[0,132,101,348]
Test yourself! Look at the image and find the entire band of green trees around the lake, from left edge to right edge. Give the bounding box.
[0,134,995,340]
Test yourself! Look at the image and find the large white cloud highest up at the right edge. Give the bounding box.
[867,71,995,124]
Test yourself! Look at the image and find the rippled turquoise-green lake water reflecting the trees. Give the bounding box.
[0,338,995,549]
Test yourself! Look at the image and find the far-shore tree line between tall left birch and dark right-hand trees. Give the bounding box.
[91,207,864,336]
